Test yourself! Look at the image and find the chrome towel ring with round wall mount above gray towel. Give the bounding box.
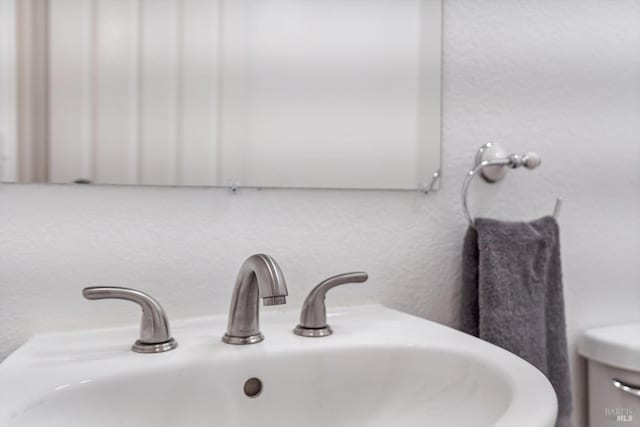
[462,142,562,228]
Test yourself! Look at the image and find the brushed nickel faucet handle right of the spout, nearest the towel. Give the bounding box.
[293,272,369,337]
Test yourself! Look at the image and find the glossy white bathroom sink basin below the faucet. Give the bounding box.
[0,306,556,427]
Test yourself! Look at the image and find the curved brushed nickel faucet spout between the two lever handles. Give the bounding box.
[222,254,288,344]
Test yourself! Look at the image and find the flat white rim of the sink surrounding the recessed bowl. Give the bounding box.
[0,305,557,427]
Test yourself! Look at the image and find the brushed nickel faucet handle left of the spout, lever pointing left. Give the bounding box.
[82,286,178,353]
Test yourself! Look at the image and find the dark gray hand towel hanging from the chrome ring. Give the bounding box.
[461,216,572,427]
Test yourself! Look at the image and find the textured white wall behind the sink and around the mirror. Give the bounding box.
[0,0,640,427]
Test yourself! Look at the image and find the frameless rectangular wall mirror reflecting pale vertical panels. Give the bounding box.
[0,0,441,190]
